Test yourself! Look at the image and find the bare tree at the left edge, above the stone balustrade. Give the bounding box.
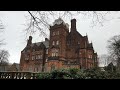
[0,50,10,65]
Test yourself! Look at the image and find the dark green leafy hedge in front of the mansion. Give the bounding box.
[38,68,120,79]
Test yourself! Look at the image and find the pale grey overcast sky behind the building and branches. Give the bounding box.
[0,11,120,66]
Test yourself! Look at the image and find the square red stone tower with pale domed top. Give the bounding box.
[48,18,69,70]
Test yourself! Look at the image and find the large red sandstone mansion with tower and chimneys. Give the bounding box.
[20,18,97,72]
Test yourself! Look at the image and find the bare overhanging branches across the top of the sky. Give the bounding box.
[26,11,111,37]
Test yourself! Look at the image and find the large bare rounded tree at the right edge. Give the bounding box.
[108,35,120,70]
